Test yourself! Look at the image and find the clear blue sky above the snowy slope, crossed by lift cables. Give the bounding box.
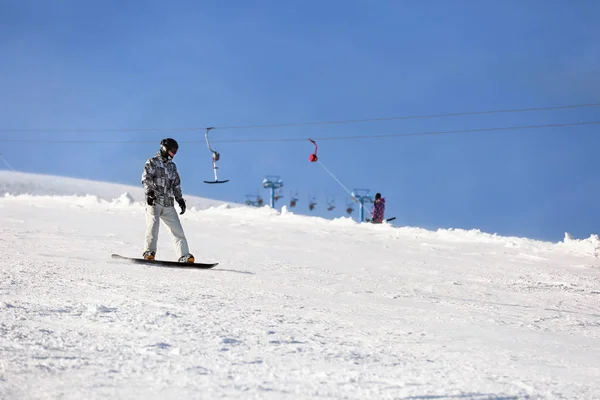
[0,0,600,240]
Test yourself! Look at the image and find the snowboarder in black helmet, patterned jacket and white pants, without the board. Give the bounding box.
[142,138,194,263]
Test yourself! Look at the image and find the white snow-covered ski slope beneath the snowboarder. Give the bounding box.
[0,172,600,400]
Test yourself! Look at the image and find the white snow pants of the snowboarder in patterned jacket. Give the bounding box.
[144,204,190,258]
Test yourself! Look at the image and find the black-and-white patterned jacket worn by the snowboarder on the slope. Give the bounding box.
[142,151,183,207]
